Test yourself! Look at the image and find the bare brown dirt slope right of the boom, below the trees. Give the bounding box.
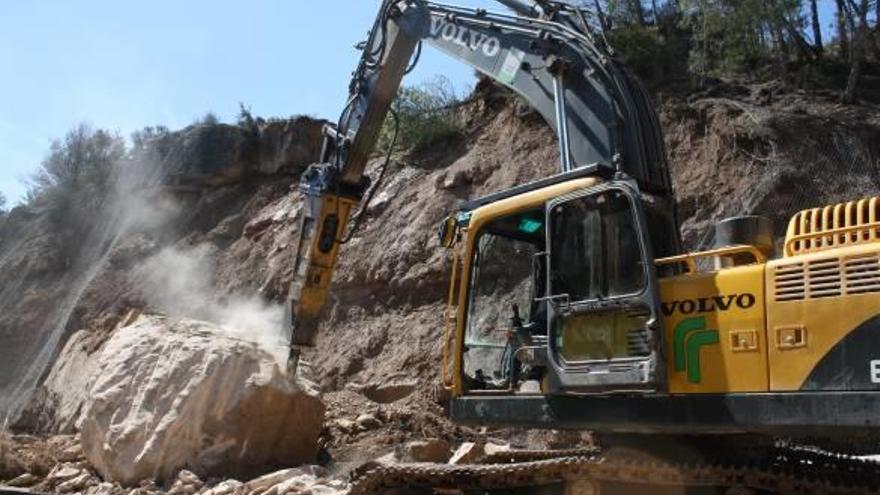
[660,81,880,248]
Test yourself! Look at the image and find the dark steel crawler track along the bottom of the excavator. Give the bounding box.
[350,449,880,495]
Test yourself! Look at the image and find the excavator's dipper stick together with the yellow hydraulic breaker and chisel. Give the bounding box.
[288,0,422,371]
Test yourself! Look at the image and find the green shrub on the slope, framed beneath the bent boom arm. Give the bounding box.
[378,77,464,152]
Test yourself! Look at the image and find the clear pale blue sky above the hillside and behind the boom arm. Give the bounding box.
[0,0,831,205]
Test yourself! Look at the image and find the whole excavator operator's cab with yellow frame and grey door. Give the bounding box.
[441,172,664,394]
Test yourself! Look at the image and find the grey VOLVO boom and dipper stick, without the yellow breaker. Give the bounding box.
[316,0,671,194]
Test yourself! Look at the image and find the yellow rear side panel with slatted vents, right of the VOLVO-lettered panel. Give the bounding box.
[766,244,880,391]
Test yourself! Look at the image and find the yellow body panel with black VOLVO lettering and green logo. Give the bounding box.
[660,264,768,393]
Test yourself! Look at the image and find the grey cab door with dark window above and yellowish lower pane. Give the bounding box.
[543,183,666,393]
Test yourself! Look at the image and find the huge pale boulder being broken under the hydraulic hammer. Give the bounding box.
[81,316,324,485]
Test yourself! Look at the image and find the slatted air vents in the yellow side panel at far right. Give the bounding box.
[773,254,880,302]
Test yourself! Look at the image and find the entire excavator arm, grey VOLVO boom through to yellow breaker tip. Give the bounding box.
[289,0,672,363]
